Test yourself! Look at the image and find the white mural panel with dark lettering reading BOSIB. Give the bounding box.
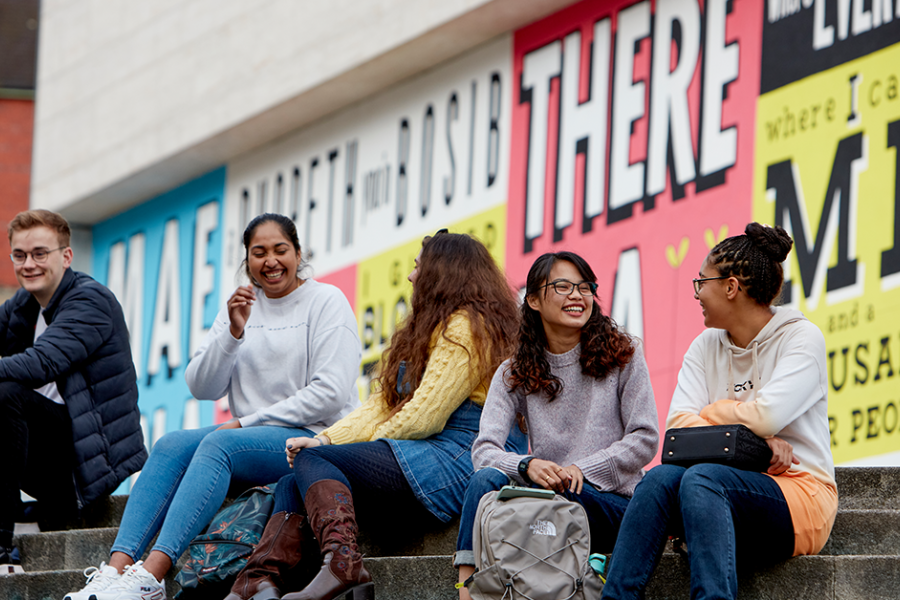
[220,35,512,302]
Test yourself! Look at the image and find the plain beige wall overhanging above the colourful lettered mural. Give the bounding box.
[31,0,572,223]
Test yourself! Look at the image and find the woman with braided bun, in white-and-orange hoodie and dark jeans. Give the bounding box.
[603,223,838,600]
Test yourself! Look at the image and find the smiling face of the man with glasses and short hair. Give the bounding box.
[10,226,72,307]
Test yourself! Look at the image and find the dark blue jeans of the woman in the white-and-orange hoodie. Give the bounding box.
[603,464,794,600]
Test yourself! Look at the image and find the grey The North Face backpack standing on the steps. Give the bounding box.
[466,488,603,600]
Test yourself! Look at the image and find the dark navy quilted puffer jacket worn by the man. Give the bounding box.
[0,269,147,508]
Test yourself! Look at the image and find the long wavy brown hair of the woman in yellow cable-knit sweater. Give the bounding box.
[376,231,518,415]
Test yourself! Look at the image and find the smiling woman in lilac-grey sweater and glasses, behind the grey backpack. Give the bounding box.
[454,252,659,599]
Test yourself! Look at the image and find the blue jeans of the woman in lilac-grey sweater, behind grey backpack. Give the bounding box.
[453,468,628,567]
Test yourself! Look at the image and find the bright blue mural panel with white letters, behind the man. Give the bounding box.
[93,167,226,446]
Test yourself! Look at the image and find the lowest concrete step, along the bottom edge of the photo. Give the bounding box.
[0,554,900,600]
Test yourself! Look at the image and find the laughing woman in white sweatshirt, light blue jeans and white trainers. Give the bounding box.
[65,213,361,600]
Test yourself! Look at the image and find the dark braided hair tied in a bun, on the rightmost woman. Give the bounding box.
[708,223,794,306]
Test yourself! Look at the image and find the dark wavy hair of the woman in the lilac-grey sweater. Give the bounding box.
[506,252,634,402]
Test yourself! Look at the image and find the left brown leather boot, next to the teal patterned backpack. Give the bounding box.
[225,512,312,600]
